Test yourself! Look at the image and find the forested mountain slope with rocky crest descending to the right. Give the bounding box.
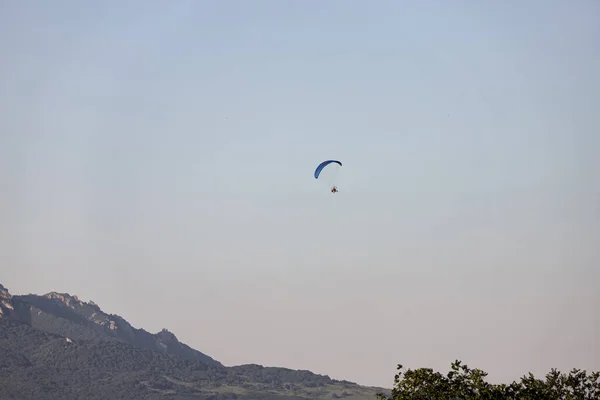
[0,285,389,400]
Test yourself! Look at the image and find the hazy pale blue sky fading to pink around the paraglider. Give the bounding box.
[0,0,600,387]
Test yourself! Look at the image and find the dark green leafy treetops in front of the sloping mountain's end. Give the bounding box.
[377,360,600,400]
